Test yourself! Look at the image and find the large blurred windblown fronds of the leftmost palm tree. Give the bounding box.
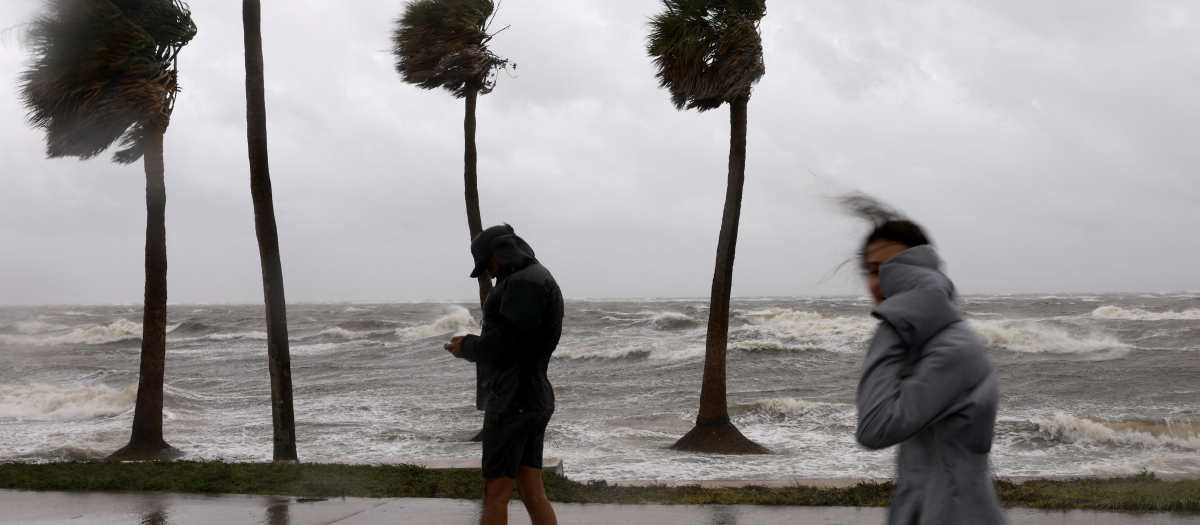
[20,0,196,164]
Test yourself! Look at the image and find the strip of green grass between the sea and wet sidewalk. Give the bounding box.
[0,461,1200,511]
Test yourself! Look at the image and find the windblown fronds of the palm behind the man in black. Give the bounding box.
[391,0,509,98]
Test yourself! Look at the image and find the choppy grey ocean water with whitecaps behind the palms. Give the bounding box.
[0,292,1200,481]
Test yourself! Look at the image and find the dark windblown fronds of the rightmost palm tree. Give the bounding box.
[647,0,767,111]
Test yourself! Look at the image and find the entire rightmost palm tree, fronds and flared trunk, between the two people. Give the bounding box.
[647,0,769,453]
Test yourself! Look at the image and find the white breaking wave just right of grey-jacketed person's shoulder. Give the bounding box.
[970,320,1129,354]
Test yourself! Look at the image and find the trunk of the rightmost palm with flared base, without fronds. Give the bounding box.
[671,95,770,454]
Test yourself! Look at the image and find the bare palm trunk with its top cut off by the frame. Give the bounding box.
[241,0,296,461]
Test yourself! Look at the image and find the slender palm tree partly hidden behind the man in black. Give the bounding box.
[391,0,516,307]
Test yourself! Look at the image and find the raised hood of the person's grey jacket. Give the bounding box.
[871,245,962,349]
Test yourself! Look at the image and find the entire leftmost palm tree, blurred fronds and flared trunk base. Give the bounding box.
[20,0,196,460]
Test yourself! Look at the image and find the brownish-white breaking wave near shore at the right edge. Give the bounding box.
[1033,412,1200,449]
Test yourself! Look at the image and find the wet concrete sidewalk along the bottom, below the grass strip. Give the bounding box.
[0,490,1200,525]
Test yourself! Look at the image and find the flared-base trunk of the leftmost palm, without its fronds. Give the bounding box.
[108,125,182,461]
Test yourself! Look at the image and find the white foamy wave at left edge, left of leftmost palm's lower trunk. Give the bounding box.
[0,384,138,420]
